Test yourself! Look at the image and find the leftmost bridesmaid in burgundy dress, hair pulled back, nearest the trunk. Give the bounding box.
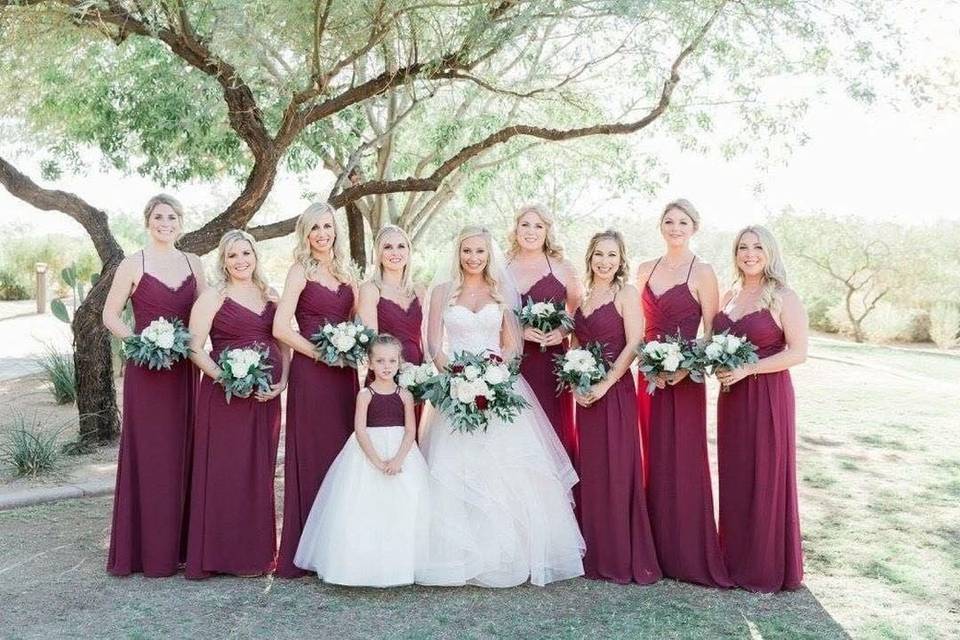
[103,194,206,577]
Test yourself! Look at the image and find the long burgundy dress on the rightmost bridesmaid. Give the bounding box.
[713,309,803,592]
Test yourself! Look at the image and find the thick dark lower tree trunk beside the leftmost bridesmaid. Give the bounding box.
[73,264,122,448]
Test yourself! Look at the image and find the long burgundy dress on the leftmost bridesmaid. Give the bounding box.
[107,256,198,577]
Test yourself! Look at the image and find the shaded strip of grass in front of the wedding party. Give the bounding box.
[0,498,849,640]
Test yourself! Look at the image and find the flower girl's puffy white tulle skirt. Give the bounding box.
[294,427,429,587]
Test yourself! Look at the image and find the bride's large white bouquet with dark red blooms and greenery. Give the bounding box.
[423,352,530,433]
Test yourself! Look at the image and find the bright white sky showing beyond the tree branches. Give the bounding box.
[0,0,960,238]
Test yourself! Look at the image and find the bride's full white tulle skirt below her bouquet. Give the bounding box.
[416,379,585,587]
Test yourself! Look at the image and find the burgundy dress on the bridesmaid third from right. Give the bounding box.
[574,301,661,584]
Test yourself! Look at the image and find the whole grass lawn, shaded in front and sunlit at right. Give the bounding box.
[0,341,960,640]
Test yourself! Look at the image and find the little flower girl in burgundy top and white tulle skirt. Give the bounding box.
[294,334,429,587]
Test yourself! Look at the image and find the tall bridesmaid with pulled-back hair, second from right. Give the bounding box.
[637,199,733,587]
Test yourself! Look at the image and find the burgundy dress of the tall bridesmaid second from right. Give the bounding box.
[637,259,733,587]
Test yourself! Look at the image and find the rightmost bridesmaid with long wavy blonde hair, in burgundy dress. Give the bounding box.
[713,226,807,592]
